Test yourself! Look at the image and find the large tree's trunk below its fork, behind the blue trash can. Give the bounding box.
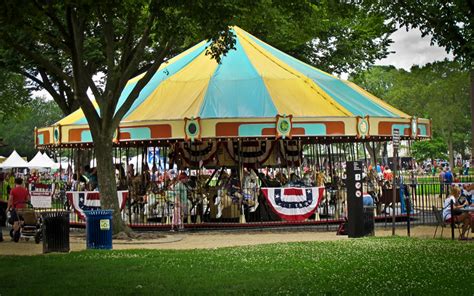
[94,137,129,233]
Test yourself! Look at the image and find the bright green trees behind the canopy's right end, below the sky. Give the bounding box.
[350,60,471,161]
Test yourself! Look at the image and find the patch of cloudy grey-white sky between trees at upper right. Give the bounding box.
[376,28,453,70]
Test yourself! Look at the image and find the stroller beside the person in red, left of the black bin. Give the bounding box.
[8,203,43,244]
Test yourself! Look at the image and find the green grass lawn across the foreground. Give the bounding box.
[0,237,474,295]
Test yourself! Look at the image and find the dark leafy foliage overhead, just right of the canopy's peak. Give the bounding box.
[235,0,394,73]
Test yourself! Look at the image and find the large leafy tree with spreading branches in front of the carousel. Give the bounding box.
[0,0,322,232]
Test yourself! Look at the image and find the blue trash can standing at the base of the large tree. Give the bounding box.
[84,210,113,250]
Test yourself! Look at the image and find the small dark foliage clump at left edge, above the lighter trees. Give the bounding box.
[0,69,30,122]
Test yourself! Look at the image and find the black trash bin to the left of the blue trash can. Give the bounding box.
[41,211,70,253]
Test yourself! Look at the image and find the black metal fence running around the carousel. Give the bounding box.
[8,182,462,230]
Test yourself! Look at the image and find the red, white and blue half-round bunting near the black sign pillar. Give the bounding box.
[262,187,324,221]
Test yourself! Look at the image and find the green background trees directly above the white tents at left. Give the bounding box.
[0,99,62,159]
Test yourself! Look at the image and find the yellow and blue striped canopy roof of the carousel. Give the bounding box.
[59,27,410,125]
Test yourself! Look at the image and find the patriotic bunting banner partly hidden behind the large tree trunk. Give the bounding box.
[66,190,128,219]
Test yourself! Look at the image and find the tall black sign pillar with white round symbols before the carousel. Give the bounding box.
[346,161,364,237]
